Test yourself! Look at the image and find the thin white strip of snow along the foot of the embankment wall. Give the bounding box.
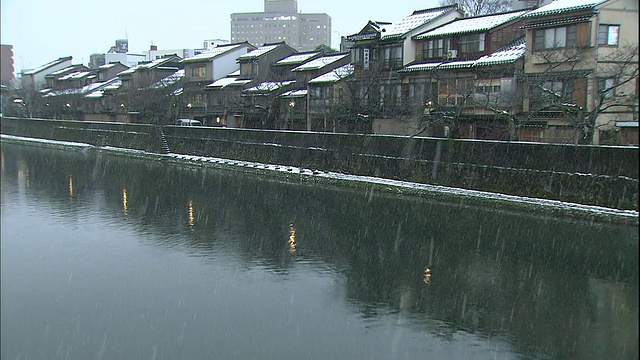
[1,134,639,218]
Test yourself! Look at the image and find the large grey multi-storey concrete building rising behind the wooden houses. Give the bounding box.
[231,0,331,51]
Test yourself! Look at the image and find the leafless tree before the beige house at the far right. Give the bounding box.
[525,45,638,144]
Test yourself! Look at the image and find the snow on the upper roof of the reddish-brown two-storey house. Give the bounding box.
[415,10,530,40]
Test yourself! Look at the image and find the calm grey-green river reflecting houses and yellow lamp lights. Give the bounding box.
[1,143,638,360]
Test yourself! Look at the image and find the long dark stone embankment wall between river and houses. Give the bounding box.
[2,118,638,210]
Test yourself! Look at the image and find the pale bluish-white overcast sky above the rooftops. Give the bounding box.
[0,0,438,73]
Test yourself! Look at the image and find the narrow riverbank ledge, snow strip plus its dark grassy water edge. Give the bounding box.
[1,134,638,225]
